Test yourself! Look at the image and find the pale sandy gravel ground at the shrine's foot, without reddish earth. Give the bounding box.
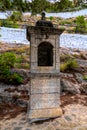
[0,104,87,130]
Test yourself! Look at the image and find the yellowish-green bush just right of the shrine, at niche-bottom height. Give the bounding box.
[60,59,79,72]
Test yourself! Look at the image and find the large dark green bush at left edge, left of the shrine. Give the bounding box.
[0,52,23,84]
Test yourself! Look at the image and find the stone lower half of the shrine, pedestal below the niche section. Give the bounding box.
[29,74,62,121]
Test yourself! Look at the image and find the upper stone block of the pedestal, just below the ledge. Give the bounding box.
[31,77,60,94]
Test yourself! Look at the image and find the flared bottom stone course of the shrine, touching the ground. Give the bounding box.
[28,107,63,123]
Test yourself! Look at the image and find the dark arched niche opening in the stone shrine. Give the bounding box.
[38,42,53,66]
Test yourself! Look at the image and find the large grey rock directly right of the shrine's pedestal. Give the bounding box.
[61,79,80,94]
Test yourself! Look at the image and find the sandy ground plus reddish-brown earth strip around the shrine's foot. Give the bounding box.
[0,95,87,130]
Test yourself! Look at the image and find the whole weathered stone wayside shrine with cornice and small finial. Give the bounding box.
[27,12,64,122]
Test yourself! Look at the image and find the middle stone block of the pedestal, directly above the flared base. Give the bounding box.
[30,93,60,109]
